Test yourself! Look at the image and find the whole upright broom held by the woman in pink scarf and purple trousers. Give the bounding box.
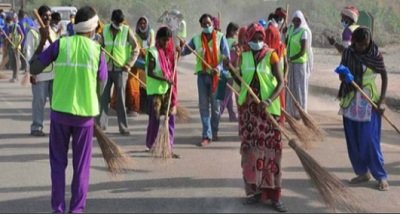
[150,53,179,160]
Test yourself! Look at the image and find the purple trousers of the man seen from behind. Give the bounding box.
[49,120,93,213]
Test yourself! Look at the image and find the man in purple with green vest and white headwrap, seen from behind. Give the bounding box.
[30,6,107,213]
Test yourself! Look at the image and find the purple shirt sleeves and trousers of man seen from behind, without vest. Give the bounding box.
[38,38,107,213]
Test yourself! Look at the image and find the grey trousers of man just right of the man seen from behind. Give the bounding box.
[97,71,128,132]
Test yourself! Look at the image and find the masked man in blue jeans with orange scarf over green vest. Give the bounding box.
[181,14,230,146]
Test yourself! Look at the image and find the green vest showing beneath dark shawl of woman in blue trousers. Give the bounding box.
[340,68,380,108]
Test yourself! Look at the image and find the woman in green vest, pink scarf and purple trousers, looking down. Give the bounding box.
[146,27,180,158]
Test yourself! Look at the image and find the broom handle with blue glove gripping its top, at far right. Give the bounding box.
[335,65,400,134]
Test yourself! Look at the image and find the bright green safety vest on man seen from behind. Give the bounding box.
[51,35,100,117]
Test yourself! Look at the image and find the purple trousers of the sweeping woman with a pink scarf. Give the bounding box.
[146,95,175,149]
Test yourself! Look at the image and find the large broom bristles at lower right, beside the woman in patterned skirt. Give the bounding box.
[288,139,366,213]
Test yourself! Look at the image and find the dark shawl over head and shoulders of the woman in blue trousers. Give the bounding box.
[338,27,386,97]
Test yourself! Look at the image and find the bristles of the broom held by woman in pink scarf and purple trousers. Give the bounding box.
[150,118,172,160]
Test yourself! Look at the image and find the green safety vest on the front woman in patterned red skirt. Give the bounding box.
[238,51,281,116]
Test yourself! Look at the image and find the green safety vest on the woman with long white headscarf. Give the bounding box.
[287,26,308,64]
